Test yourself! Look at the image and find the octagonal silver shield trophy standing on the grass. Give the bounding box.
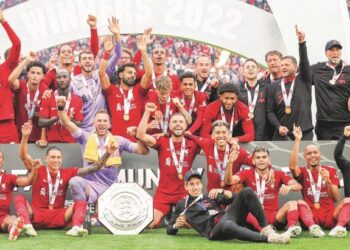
[98,183,153,235]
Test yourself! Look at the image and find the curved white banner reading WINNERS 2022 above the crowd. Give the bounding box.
[0,0,286,64]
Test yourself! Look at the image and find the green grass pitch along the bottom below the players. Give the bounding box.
[0,227,350,250]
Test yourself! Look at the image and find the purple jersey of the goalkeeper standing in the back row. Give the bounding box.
[70,71,107,132]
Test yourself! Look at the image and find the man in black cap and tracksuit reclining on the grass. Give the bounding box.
[167,170,290,244]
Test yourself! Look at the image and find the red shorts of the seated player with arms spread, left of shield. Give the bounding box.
[32,207,68,229]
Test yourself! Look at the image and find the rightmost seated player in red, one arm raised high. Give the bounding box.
[289,126,350,237]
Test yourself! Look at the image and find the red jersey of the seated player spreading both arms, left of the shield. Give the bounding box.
[32,166,79,208]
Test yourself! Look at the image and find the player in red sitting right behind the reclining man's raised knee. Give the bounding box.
[225,146,301,237]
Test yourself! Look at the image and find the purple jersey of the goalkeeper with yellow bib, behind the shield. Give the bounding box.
[72,128,137,186]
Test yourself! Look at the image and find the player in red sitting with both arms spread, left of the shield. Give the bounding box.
[14,122,117,236]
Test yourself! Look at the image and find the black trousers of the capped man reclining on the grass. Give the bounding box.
[209,188,267,242]
